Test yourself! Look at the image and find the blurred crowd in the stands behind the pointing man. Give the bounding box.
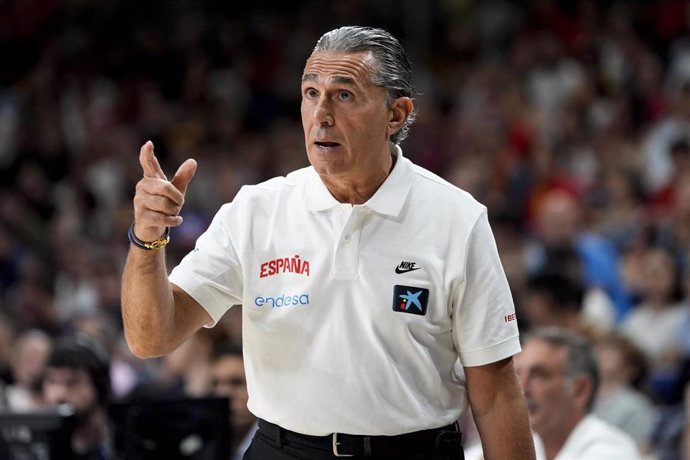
[0,0,690,458]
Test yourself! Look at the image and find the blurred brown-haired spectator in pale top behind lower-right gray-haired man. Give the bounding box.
[593,334,659,454]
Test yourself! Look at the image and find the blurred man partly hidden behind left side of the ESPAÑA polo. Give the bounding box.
[211,344,257,460]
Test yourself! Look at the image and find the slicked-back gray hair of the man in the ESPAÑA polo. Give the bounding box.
[312,26,417,144]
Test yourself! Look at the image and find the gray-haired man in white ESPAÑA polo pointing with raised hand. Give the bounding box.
[123,27,534,459]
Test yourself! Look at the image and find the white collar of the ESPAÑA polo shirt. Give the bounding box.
[305,145,414,216]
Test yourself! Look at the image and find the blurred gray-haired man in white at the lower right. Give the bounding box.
[515,328,640,460]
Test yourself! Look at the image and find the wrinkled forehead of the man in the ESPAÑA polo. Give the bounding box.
[302,51,374,86]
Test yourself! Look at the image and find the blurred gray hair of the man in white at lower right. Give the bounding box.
[525,327,599,411]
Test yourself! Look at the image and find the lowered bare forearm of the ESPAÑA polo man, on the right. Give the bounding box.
[465,358,535,460]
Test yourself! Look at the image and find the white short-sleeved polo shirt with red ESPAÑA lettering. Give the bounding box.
[170,148,520,435]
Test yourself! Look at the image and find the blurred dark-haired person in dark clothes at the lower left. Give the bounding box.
[43,337,112,460]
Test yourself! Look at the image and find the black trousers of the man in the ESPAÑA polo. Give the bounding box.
[243,420,464,460]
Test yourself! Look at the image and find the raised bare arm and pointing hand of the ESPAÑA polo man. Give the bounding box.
[122,141,210,358]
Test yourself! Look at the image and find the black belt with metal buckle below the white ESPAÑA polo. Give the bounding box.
[259,419,463,460]
